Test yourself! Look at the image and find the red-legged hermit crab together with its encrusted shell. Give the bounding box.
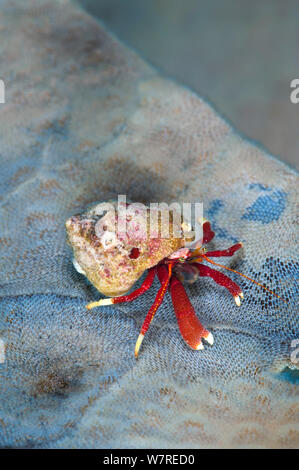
[66,202,284,358]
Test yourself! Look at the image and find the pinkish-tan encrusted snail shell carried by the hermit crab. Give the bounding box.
[66,203,185,297]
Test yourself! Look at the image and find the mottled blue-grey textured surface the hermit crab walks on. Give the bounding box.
[0,0,299,448]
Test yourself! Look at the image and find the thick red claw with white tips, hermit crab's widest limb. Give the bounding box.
[169,276,214,350]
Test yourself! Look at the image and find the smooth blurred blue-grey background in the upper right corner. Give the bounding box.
[79,0,299,168]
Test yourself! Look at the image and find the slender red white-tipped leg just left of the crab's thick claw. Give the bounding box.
[135,264,172,358]
